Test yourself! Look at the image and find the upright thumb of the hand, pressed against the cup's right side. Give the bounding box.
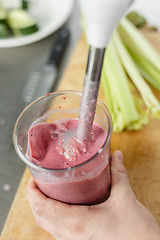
[111,151,132,198]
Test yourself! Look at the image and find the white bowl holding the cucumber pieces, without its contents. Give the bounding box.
[0,0,73,48]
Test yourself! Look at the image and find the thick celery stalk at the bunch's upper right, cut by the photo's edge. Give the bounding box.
[118,18,160,70]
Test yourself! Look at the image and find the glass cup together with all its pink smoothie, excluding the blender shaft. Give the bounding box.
[14,91,112,204]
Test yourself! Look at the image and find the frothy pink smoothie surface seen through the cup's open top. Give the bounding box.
[28,119,106,169]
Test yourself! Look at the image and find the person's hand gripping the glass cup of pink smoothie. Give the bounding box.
[27,151,160,240]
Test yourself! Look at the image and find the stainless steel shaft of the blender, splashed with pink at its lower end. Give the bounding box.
[76,46,105,141]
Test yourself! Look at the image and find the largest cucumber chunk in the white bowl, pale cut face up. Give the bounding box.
[8,9,39,35]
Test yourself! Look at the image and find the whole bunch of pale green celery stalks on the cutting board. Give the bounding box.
[102,15,160,132]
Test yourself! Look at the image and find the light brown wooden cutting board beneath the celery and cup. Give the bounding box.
[0,31,160,240]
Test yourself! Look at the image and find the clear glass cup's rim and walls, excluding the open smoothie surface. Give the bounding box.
[13,91,112,204]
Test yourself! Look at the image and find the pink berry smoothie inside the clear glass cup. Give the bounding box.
[27,119,110,204]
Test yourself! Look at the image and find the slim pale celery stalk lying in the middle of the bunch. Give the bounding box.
[113,31,160,114]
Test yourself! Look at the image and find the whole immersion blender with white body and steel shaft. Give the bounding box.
[76,0,134,141]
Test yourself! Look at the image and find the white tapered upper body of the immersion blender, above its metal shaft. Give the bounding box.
[79,0,134,48]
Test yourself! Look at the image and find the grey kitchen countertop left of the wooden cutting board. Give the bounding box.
[0,1,81,232]
